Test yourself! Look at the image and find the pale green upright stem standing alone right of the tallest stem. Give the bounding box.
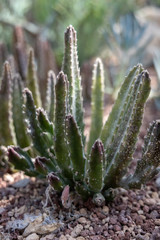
[88,58,104,154]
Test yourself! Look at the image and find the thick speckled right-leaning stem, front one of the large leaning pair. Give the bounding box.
[104,70,150,187]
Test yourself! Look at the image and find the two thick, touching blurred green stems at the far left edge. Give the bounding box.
[0,62,31,167]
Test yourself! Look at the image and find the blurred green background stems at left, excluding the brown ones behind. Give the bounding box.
[0,49,41,165]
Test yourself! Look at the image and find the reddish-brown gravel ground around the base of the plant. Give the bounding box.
[0,66,160,240]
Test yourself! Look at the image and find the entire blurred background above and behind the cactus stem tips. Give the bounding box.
[0,0,160,102]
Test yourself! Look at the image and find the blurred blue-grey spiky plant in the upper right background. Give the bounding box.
[104,12,152,97]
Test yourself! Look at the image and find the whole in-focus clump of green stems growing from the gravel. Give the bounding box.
[8,26,160,207]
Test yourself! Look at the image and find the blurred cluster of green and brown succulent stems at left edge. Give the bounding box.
[0,26,56,167]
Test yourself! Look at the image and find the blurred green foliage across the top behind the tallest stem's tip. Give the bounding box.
[0,0,148,63]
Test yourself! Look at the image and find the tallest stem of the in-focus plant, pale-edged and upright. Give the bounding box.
[62,26,85,141]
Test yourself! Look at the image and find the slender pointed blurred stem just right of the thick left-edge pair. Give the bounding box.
[26,49,41,107]
